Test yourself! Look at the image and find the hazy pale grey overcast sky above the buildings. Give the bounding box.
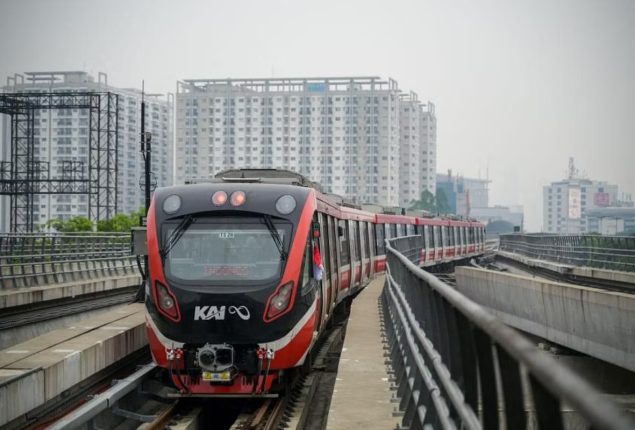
[0,0,635,230]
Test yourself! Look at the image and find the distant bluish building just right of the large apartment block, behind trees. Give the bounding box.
[436,170,490,216]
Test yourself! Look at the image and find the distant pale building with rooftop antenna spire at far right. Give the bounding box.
[543,159,632,234]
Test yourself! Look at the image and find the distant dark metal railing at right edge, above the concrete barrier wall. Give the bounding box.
[500,234,635,272]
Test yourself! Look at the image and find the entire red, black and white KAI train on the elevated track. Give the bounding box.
[146,169,484,396]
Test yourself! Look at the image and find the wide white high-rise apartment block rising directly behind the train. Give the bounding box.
[175,77,436,206]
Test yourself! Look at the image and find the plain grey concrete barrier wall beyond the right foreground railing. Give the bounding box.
[456,267,635,371]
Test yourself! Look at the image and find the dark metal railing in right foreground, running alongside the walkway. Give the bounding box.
[382,238,635,429]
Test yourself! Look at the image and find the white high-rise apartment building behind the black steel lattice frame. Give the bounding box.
[0,71,174,230]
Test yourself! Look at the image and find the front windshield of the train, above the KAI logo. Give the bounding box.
[163,218,291,284]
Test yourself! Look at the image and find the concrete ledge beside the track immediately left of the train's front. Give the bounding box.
[0,304,147,426]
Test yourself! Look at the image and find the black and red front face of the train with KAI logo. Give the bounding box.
[146,182,317,396]
